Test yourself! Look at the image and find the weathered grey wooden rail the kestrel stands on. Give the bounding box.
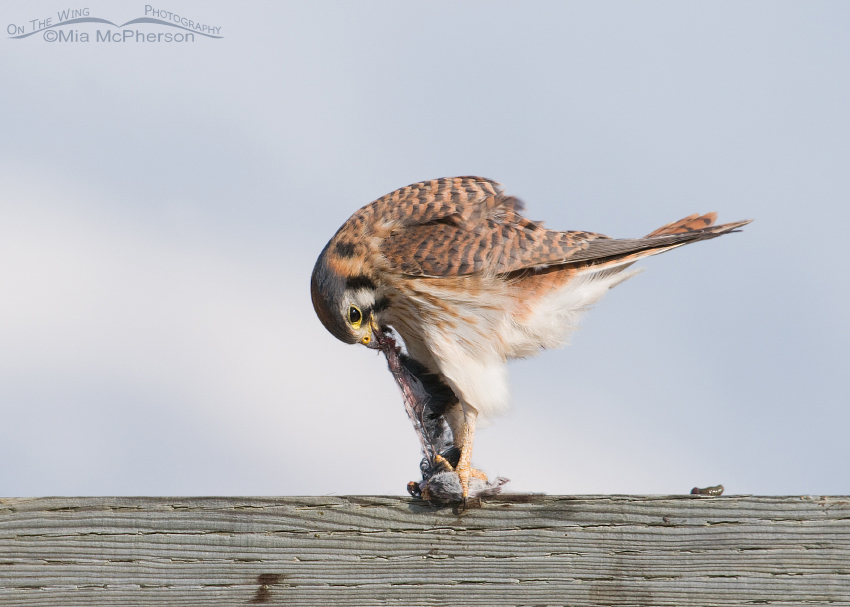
[0,495,850,607]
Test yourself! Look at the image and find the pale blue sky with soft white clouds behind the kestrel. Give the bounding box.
[0,1,850,495]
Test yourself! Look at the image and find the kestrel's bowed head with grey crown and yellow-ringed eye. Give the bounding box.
[310,244,386,348]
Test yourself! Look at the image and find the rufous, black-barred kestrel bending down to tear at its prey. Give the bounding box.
[310,177,749,500]
